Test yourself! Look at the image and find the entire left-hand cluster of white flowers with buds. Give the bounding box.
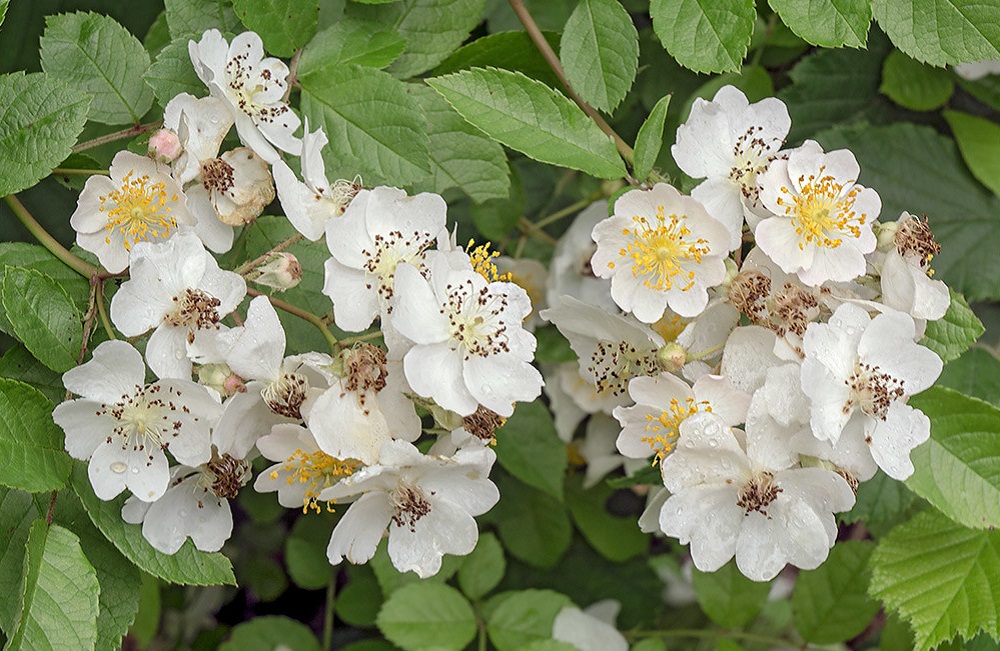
[54,30,542,576]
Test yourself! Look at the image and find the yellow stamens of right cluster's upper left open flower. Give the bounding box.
[610,206,709,291]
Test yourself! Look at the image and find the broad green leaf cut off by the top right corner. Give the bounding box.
[872,0,1000,66]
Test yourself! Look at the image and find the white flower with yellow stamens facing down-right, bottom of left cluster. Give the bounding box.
[253,423,360,513]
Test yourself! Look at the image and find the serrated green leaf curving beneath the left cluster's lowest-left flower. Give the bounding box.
[71,462,236,585]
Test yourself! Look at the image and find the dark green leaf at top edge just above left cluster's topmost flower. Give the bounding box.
[233,0,319,57]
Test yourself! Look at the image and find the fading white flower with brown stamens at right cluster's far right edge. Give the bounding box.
[876,212,951,321]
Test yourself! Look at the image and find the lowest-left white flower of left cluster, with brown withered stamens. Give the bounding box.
[122,445,250,554]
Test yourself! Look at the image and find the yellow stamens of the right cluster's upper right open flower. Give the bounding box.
[778,166,867,250]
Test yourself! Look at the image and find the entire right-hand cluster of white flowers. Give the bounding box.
[541,86,950,580]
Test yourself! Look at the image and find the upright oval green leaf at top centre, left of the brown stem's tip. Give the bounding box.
[559,0,639,113]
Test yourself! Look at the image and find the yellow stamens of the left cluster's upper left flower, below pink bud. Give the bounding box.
[99,170,177,251]
